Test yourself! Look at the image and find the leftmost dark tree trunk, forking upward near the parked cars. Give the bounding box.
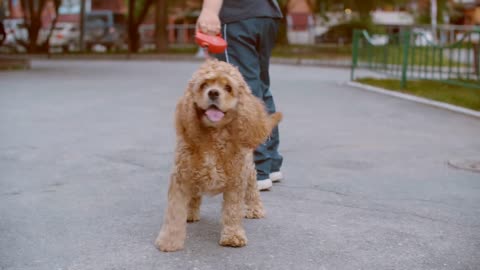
[18,0,62,53]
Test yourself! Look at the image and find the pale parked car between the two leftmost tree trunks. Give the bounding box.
[49,23,80,52]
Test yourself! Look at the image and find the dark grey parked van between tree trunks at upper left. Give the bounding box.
[84,11,127,51]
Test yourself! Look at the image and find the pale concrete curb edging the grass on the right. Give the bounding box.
[347,81,480,118]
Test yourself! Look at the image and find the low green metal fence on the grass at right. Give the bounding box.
[351,29,480,89]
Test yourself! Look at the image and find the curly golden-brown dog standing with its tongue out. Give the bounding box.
[155,60,282,251]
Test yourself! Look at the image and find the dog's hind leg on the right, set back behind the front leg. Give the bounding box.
[245,169,265,218]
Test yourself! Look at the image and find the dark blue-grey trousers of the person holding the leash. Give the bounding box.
[216,18,283,180]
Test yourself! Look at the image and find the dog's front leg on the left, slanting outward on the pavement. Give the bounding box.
[155,174,189,251]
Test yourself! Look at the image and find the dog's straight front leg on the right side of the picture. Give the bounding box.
[220,187,247,247]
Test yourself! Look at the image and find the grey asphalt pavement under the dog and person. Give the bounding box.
[0,60,480,270]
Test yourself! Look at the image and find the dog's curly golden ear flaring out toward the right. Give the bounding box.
[236,83,282,149]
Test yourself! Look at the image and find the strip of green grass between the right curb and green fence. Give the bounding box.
[357,78,480,111]
